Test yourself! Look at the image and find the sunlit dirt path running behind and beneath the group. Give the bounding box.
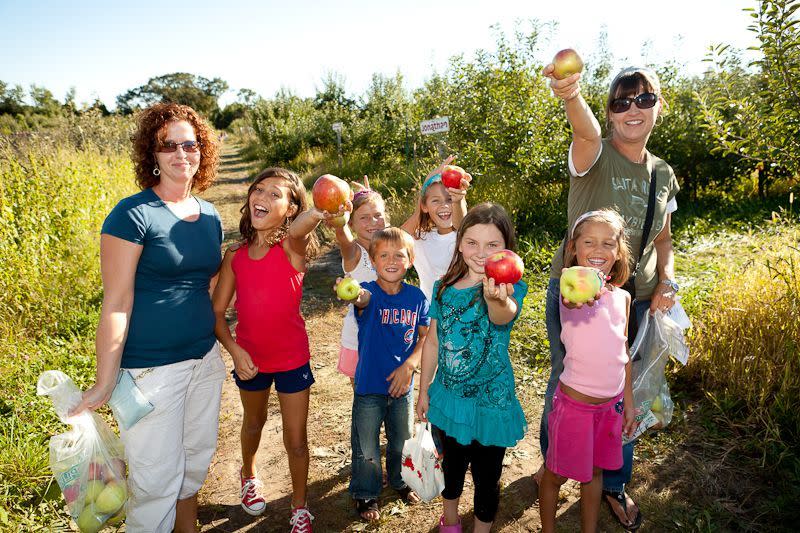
[195,145,579,532]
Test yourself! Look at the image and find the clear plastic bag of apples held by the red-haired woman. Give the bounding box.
[36,370,128,533]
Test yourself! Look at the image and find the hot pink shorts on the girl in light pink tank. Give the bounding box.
[546,383,623,483]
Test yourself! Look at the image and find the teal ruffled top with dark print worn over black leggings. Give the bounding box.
[428,281,528,448]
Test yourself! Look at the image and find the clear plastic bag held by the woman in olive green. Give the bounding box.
[622,311,689,444]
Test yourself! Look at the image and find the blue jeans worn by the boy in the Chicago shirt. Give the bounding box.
[350,389,414,500]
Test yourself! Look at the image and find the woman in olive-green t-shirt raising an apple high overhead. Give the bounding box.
[536,64,679,531]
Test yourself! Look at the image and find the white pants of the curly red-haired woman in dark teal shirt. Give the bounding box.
[120,342,226,533]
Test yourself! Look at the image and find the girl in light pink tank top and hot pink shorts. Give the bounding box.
[539,209,635,533]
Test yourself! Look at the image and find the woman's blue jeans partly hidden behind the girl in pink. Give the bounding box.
[539,278,650,492]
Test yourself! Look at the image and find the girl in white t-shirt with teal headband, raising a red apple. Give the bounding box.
[401,156,472,302]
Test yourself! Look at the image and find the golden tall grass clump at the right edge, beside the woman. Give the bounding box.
[686,226,800,517]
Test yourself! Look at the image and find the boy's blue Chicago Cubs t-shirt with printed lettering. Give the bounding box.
[355,281,430,394]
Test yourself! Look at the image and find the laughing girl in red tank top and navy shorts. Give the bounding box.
[212,168,350,533]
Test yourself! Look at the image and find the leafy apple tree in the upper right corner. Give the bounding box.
[697,0,800,196]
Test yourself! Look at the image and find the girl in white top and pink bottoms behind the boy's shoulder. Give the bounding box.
[333,176,389,384]
